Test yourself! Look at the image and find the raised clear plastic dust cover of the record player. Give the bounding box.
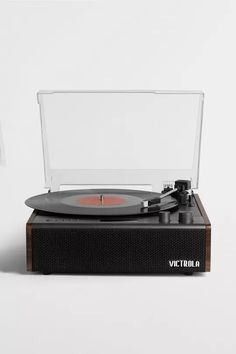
[38,91,204,191]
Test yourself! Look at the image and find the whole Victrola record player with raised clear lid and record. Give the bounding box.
[26,91,211,274]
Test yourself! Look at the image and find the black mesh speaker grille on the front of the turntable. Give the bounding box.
[32,227,205,274]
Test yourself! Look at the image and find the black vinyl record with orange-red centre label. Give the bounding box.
[25,189,178,216]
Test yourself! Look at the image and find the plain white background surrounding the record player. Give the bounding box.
[0,0,236,354]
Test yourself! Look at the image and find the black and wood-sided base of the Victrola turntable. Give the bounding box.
[27,195,211,274]
